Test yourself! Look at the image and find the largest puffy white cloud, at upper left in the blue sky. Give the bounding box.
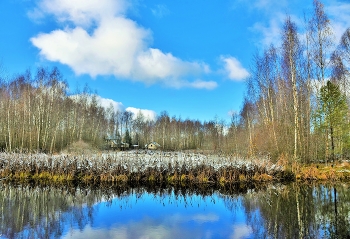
[30,0,214,89]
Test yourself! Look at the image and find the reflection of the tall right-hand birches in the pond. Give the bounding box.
[239,184,350,238]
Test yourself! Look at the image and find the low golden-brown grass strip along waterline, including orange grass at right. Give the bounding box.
[0,164,350,186]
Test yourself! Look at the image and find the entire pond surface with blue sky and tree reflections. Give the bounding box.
[0,183,350,239]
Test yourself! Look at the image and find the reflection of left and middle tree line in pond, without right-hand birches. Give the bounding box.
[0,184,266,238]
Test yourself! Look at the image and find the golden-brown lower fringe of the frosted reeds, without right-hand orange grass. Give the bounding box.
[0,170,294,186]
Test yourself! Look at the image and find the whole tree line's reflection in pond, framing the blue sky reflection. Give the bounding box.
[0,184,350,238]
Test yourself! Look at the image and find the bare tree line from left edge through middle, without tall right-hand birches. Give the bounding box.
[0,68,230,153]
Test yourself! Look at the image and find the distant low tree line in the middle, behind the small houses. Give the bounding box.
[107,109,229,150]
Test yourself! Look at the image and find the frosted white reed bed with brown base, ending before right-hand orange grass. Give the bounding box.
[0,152,295,185]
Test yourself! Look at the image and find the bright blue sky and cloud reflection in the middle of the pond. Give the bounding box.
[64,190,252,239]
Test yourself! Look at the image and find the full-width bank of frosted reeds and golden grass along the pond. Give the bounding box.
[0,150,350,187]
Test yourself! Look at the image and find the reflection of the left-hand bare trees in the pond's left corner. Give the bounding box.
[0,185,97,238]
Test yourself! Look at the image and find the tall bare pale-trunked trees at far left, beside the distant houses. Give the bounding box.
[0,68,106,152]
